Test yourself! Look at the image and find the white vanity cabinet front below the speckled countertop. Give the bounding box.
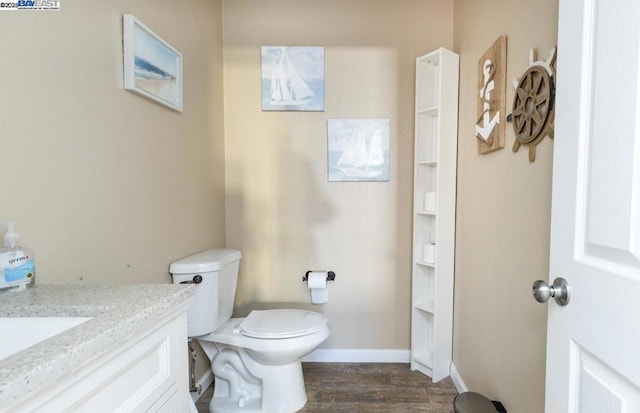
[9,308,189,413]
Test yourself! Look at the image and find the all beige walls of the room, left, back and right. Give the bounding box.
[0,0,557,402]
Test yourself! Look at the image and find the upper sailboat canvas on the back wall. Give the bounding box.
[262,46,324,112]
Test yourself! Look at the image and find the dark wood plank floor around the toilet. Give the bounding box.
[197,363,458,413]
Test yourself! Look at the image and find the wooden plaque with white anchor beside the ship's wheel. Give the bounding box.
[475,36,507,154]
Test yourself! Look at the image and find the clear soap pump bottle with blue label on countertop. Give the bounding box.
[0,222,36,289]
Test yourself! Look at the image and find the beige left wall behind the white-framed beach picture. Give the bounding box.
[0,0,225,284]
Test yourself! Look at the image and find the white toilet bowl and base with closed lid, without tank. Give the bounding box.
[197,310,329,413]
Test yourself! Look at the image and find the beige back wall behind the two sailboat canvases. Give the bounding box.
[223,0,453,350]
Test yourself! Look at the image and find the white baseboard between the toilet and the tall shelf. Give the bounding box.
[302,349,411,363]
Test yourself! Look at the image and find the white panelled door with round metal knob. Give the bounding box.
[546,0,640,413]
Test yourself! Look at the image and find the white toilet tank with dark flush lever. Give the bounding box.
[169,249,241,337]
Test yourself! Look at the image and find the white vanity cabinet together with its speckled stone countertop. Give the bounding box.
[0,284,193,413]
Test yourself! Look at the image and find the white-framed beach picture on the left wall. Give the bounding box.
[123,14,182,112]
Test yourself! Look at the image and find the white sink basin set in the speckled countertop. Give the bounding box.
[0,317,91,360]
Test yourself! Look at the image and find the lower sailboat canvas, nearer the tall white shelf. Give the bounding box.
[327,119,389,182]
